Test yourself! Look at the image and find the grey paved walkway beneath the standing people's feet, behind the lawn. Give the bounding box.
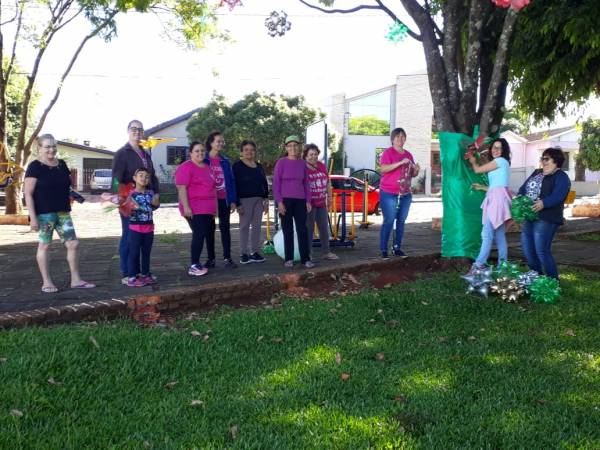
[0,214,600,313]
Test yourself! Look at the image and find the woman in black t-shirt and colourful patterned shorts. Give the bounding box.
[25,134,95,294]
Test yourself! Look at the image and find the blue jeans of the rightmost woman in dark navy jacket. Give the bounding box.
[521,220,559,279]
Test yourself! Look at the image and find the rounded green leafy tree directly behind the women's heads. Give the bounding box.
[187,92,324,166]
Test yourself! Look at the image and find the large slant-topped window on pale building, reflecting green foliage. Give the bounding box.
[348,89,392,136]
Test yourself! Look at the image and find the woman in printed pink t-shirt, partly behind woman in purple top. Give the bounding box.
[302,144,338,259]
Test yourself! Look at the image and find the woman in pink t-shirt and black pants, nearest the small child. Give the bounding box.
[175,141,217,276]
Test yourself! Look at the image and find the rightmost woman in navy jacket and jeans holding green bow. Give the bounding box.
[519,147,571,279]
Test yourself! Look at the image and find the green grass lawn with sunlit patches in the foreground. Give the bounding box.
[0,268,600,449]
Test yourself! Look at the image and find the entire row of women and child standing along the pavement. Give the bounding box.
[25,120,570,293]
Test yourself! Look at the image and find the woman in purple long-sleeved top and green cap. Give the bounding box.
[273,136,315,268]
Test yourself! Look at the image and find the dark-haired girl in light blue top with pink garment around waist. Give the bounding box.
[467,138,512,275]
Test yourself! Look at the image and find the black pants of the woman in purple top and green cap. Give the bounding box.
[279,198,310,264]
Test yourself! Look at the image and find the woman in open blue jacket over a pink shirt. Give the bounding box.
[205,131,237,269]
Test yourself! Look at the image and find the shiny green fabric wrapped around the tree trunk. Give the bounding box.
[439,131,487,259]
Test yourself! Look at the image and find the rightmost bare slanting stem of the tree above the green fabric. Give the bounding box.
[479,8,517,136]
